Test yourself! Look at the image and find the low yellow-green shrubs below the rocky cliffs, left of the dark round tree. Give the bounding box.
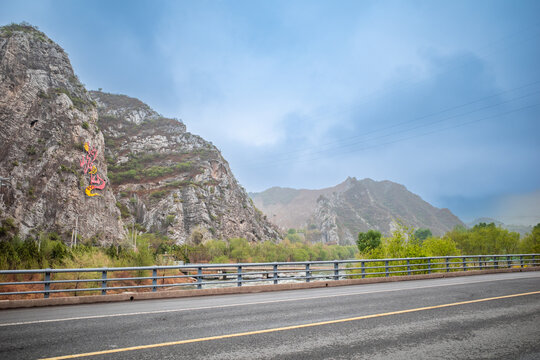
[0,233,358,269]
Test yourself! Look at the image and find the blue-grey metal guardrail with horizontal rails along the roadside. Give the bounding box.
[0,254,540,298]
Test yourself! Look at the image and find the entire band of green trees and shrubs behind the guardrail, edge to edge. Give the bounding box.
[0,217,540,269]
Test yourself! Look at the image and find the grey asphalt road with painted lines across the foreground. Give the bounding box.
[0,272,540,359]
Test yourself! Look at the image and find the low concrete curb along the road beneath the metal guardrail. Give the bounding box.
[0,266,540,310]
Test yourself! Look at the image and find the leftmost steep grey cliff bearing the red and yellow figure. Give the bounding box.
[0,25,123,242]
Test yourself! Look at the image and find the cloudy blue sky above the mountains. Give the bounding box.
[0,0,540,224]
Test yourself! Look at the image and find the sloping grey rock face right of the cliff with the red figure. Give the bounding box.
[91,91,280,243]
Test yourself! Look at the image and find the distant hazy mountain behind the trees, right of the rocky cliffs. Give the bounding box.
[250,178,463,244]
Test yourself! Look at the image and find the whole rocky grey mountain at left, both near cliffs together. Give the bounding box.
[0,24,280,244]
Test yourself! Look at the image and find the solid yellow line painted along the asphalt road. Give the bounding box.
[41,291,540,360]
